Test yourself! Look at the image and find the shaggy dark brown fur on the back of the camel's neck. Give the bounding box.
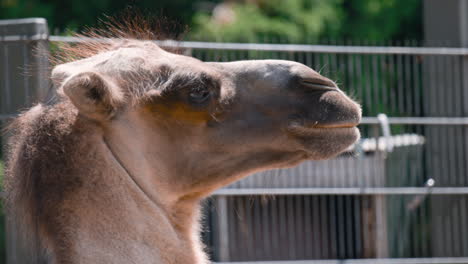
[5,101,81,257]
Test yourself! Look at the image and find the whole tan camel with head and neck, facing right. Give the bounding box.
[5,27,361,264]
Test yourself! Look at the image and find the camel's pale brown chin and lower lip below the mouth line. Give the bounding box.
[293,127,360,160]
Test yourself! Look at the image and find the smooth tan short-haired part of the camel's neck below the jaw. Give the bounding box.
[42,125,207,264]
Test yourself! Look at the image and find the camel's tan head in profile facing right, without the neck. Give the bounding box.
[52,41,361,199]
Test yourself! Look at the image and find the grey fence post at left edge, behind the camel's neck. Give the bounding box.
[0,18,50,264]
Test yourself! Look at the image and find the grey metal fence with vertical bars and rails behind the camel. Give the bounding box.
[0,18,468,264]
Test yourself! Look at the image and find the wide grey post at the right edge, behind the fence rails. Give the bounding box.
[423,0,468,257]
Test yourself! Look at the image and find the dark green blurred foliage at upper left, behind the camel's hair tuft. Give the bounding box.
[0,0,199,34]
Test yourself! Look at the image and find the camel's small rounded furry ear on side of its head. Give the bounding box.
[62,72,124,120]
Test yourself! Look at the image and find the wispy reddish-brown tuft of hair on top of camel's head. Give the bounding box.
[50,7,188,66]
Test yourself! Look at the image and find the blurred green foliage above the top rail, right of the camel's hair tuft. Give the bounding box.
[192,0,422,43]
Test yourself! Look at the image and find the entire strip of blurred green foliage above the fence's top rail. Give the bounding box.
[0,0,422,43]
